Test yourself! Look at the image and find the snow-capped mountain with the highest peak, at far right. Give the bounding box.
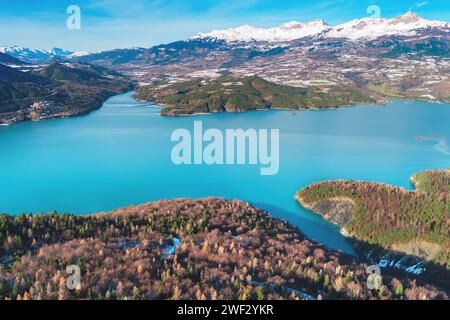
[324,12,450,40]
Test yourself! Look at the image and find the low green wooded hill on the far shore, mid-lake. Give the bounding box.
[136,76,374,115]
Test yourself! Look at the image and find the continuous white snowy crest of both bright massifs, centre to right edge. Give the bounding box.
[193,12,450,42]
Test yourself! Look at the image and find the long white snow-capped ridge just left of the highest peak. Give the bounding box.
[193,20,330,42]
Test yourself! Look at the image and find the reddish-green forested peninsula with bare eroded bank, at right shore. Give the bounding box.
[296,170,450,268]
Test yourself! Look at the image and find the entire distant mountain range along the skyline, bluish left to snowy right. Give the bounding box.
[0,12,450,64]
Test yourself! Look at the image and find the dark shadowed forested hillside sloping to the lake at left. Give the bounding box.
[0,62,133,124]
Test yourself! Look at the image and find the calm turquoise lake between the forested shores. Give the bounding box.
[0,93,450,252]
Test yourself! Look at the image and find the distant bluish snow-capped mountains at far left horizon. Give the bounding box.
[0,46,88,63]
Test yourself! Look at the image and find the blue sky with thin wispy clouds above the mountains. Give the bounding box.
[0,0,450,51]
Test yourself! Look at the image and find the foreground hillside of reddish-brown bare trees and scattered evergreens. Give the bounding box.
[0,198,448,300]
